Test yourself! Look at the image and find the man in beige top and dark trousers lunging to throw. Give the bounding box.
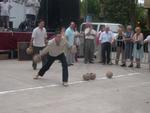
[33,34,68,86]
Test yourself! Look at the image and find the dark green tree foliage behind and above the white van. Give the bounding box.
[81,0,145,25]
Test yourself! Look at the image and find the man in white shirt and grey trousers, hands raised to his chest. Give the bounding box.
[84,23,96,64]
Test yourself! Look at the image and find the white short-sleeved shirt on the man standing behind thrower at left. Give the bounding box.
[32,27,47,47]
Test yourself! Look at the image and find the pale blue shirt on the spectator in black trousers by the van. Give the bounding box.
[99,31,113,43]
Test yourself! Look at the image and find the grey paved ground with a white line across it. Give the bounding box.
[0,60,150,113]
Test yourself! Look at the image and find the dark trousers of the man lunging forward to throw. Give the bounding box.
[38,53,68,82]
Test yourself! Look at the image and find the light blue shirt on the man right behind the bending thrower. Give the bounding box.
[65,27,75,47]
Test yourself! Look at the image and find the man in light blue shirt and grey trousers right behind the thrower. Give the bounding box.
[65,22,75,66]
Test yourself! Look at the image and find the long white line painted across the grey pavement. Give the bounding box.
[0,73,140,95]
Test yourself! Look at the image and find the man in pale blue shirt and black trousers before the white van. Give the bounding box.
[99,26,113,64]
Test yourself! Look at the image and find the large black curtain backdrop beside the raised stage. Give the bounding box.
[37,0,80,30]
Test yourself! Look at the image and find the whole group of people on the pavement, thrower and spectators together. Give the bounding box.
[30,20,150,86]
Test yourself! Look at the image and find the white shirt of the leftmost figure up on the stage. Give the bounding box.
[0,2,12,16]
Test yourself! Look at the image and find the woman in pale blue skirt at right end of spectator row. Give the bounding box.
[133,27,144,68]
